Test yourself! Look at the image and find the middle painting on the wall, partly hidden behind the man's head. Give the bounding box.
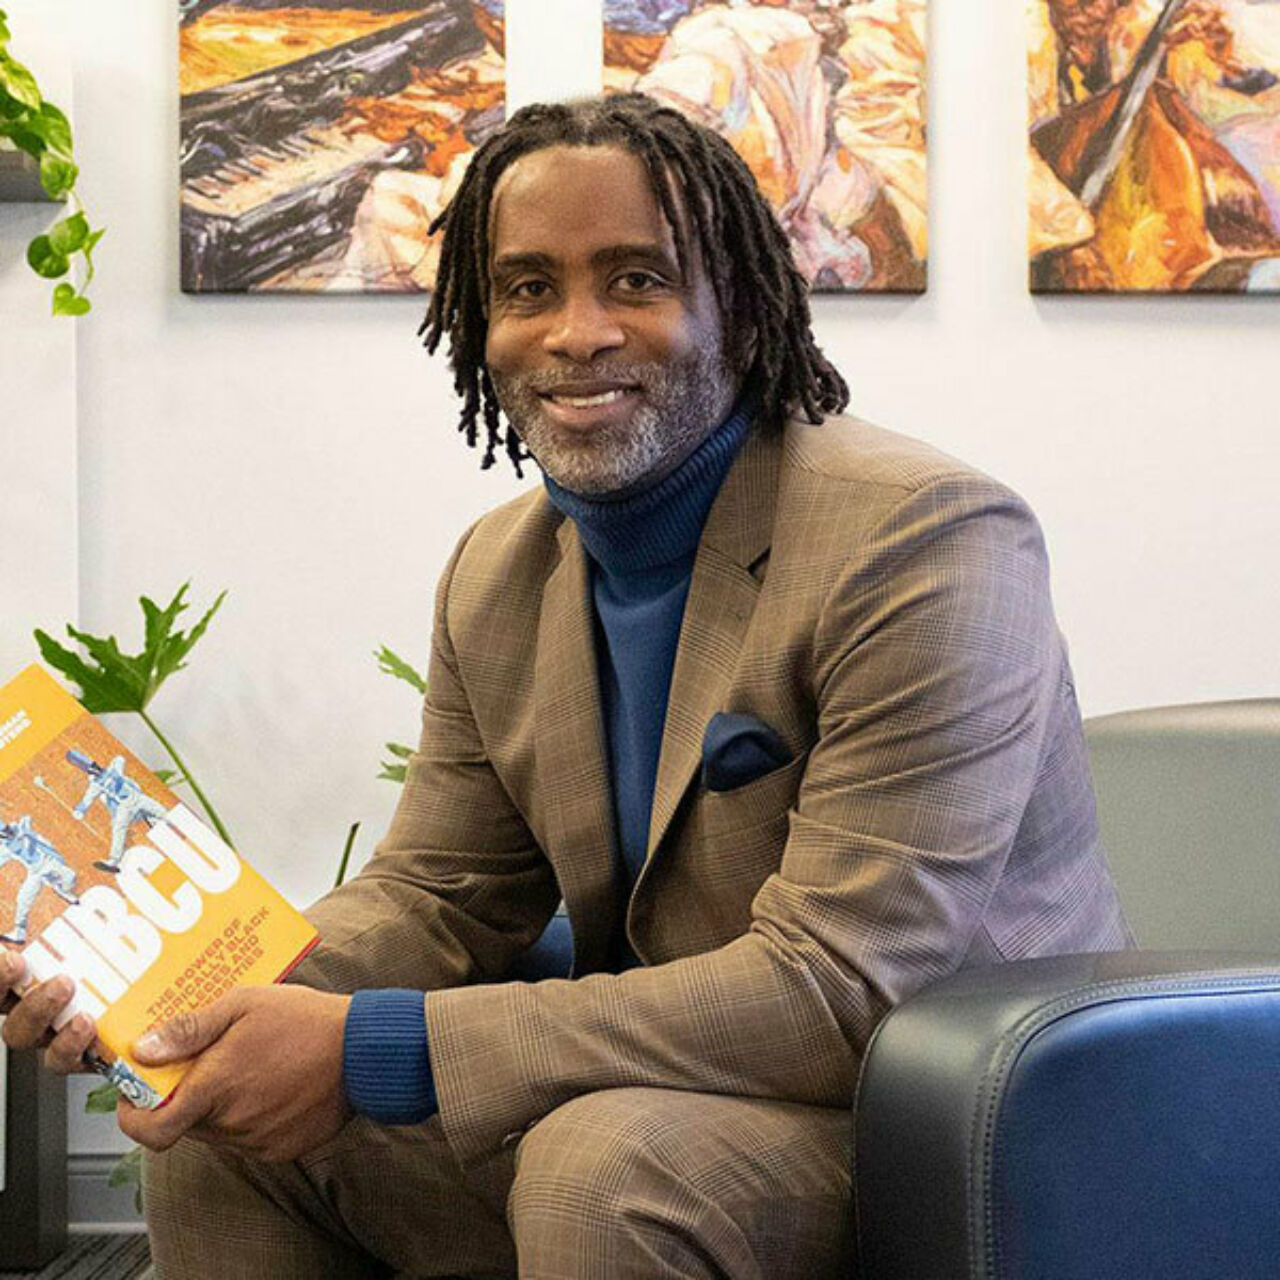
[603,0,928,293]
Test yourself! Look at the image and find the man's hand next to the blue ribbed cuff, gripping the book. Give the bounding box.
[116,987,351,1162]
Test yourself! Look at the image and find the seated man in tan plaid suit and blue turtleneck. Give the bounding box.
[10,96,1128,1280]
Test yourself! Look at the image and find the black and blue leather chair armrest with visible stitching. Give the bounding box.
[854,951,1280,1280]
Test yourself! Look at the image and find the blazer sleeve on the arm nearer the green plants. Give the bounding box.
[291,526,559,992]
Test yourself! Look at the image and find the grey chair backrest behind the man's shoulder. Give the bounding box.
[1084,698,1280,951]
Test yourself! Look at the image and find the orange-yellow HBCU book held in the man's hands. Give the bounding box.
[0,666,316,1106]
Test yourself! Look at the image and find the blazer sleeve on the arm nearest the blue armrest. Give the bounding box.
[426,474,1062,1162]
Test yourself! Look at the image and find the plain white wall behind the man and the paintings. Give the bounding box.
[0,0,1280,1162]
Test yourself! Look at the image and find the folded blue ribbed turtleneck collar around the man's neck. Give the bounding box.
[543,397,755,575]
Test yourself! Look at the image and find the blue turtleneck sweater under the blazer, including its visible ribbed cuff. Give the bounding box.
[343,403,754,1124]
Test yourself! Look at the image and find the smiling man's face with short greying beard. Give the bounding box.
[485,146,739,495]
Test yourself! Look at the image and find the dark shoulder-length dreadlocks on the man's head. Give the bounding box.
[419,93,849,475]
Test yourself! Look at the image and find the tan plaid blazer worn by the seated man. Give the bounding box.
[302,419,1130,1162]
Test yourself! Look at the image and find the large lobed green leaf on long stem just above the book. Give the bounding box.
[36,582,227,716]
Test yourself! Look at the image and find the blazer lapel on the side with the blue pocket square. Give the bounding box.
[641,430,782,874]
